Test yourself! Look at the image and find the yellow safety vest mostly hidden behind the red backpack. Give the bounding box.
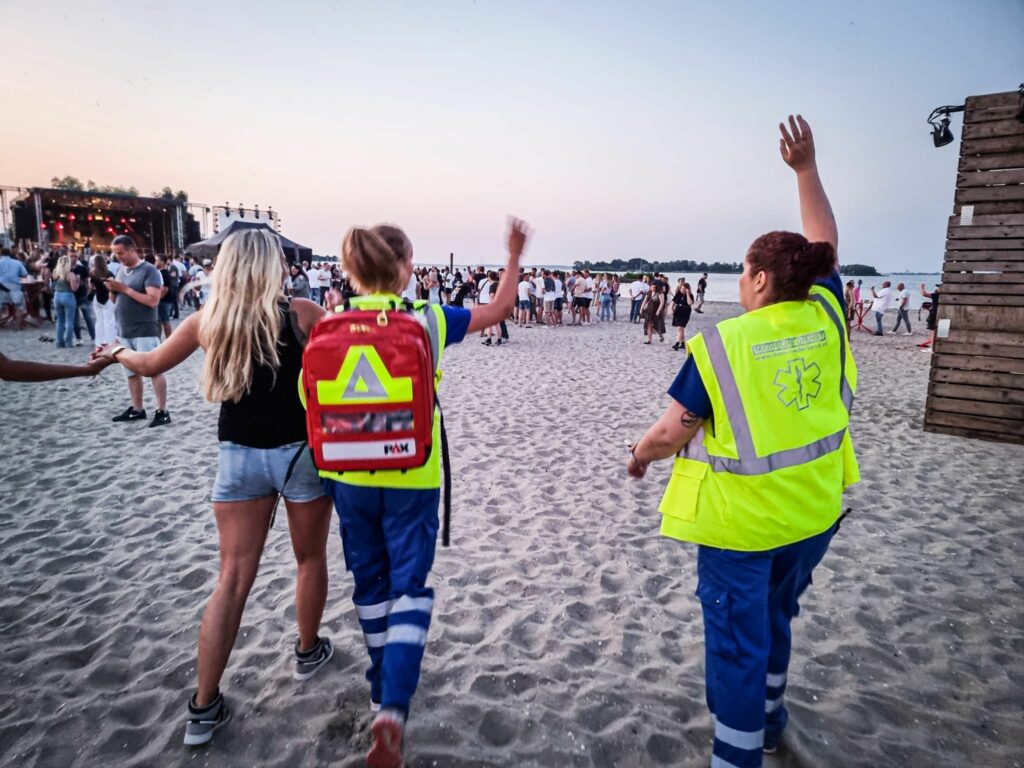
[299,294,447,489]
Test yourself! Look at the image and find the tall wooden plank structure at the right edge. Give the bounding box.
[925,91,1024,444]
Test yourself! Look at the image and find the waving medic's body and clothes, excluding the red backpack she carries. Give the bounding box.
[321,219,527,768]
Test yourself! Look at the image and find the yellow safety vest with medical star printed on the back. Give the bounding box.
[658,286,860,552]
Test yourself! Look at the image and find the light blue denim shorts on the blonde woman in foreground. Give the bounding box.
[210,440,325,502]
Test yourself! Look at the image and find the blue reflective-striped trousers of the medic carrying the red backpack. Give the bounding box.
[325,480,440,715]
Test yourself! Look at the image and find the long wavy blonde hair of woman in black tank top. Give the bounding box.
[199,229,285,402]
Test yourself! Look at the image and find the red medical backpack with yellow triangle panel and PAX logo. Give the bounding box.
[300,302,435,472]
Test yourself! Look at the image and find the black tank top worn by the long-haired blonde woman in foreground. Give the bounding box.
[217,302,306,449]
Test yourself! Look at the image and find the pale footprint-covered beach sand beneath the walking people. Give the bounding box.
[0,304,1024,768]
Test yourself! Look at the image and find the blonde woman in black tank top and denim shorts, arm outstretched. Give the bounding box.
[97,229,334,745]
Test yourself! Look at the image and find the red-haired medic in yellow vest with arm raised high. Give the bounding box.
[627,116,858,768]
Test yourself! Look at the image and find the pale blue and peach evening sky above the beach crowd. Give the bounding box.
[0,0,1024,271]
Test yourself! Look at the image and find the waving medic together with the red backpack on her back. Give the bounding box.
[300,219,527,768]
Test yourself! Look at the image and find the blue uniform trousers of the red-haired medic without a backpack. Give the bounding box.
[697,527,836,768]
